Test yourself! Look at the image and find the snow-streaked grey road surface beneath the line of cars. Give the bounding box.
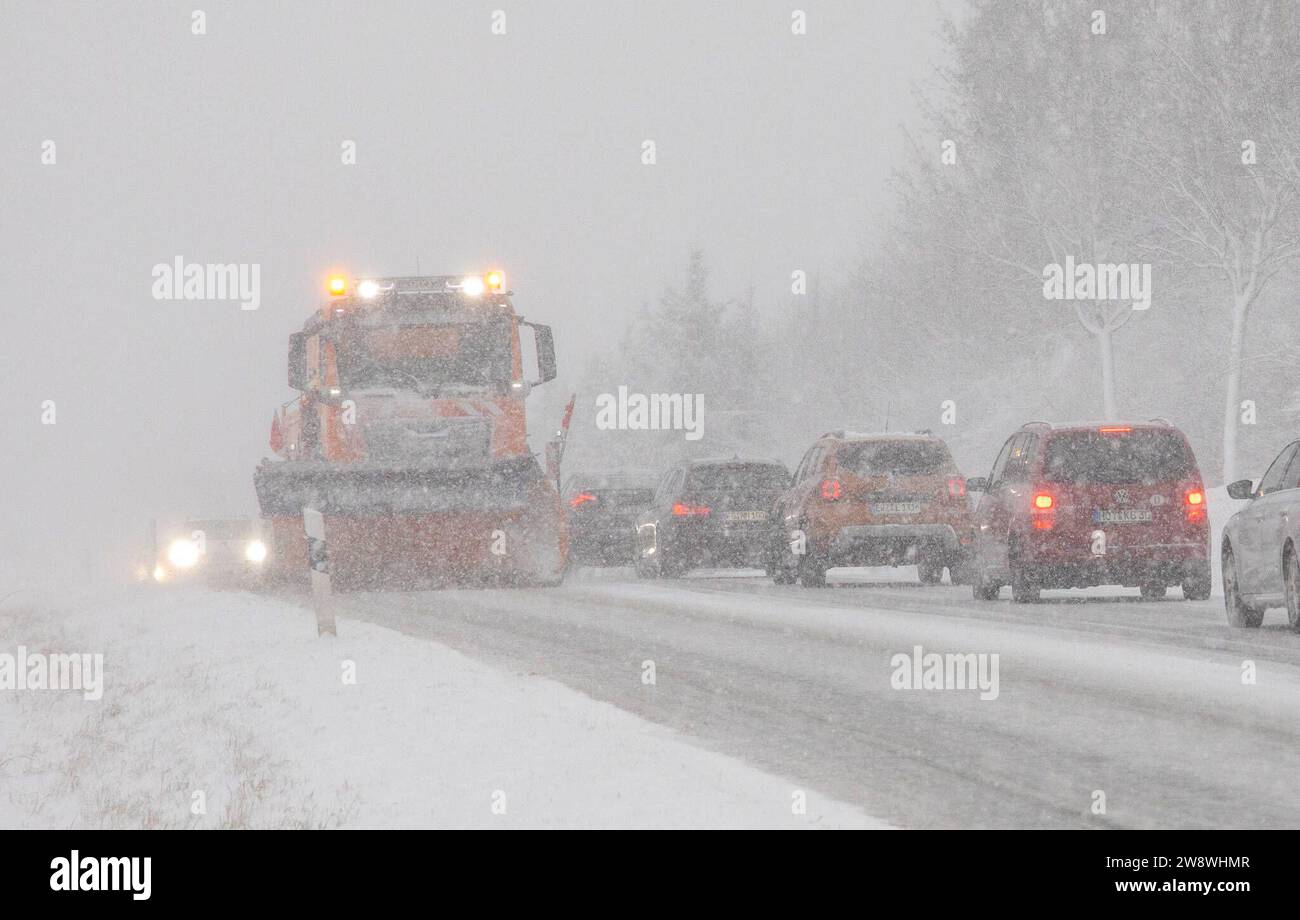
[345,569,1300,826]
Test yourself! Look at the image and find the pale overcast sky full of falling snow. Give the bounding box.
[0,0,939,571]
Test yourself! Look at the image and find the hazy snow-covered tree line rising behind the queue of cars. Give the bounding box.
[572,0,1300,482]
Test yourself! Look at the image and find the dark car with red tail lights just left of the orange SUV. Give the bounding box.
[636,456,790,578]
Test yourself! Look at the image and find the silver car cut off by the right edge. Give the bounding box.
[1223,441,1300,632]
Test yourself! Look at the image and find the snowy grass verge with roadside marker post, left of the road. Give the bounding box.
[0,589,881,828]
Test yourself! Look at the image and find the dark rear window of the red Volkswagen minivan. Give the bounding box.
[1043,430,1196,483]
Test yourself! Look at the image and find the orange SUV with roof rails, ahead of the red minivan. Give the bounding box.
[768,431,971,587]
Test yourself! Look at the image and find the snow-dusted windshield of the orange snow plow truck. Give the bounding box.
[337,320,514,392]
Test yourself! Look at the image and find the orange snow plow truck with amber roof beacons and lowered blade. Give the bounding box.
[254,272,568,587]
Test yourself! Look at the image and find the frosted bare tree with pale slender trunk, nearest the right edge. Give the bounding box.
[1136,0,1300,482]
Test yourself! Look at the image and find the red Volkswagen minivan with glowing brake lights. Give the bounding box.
[967,418,1210,603]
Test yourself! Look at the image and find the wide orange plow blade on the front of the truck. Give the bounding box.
[254,456,568,589]
